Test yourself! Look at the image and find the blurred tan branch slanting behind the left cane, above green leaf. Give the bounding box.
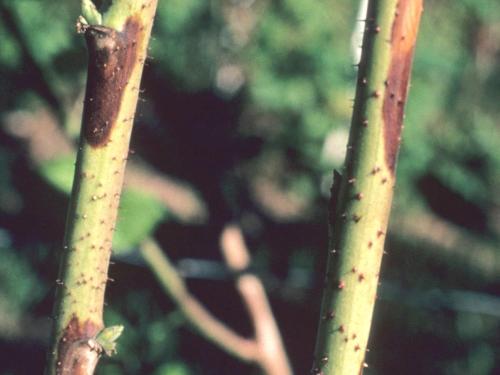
[1,108,208,223]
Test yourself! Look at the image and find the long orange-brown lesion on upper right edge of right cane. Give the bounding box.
[383,0,423,174]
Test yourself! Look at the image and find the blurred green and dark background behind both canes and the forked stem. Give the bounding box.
[0,0,500,375]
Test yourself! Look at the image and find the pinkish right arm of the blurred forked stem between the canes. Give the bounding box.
[221,225,292,375]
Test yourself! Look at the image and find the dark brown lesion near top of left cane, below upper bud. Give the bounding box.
[83,17,143,147]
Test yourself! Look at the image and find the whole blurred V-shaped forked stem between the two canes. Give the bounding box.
[140,225,292,375]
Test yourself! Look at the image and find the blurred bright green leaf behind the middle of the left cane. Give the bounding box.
[39,156,167,255]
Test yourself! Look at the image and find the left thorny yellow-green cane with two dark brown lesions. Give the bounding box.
[46,0,157,375]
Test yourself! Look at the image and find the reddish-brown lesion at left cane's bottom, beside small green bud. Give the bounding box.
[56,316,102,375]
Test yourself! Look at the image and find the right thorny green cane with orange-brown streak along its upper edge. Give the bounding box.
[312,0,423,375]
